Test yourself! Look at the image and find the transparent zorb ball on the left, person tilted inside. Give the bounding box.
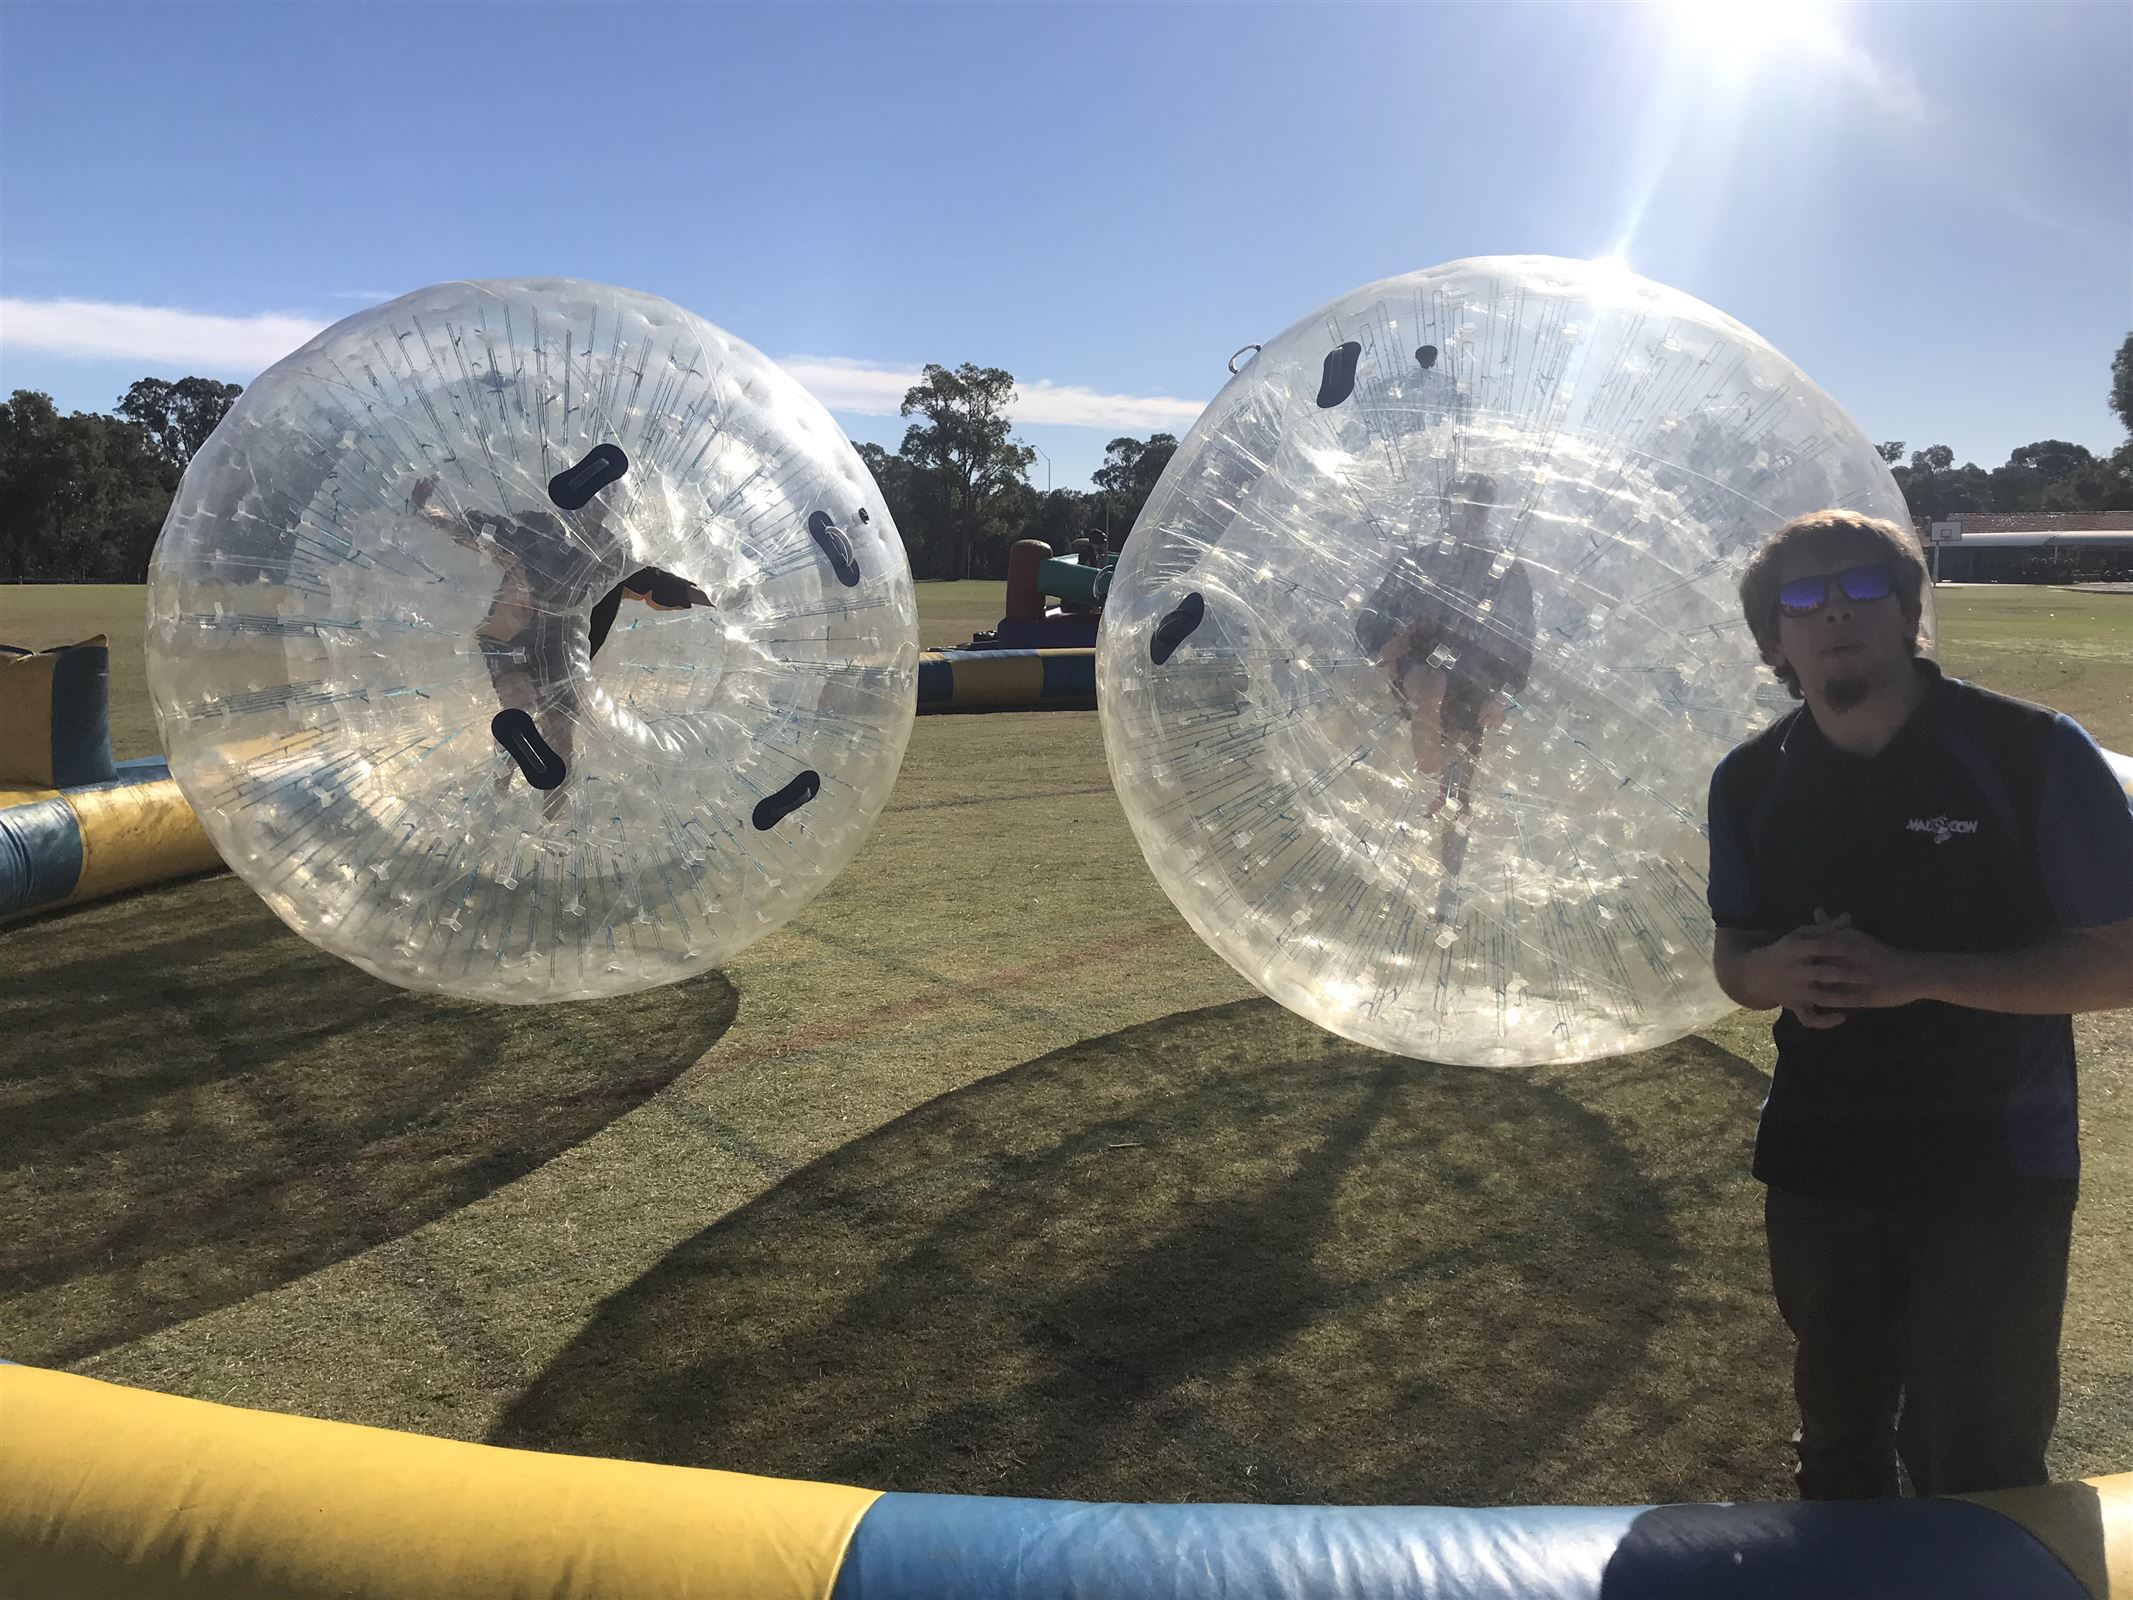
[147,279,917,1001]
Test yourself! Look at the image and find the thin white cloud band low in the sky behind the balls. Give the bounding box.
[0,290,1203,433]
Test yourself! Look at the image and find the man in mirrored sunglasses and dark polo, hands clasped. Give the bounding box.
[1711,512,2133,1500]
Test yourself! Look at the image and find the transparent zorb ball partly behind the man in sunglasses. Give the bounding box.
[1096,256,1909,1065]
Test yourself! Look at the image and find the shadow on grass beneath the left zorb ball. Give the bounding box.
[0,877,736,1363]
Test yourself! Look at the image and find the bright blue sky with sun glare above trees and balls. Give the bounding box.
[0,0,2133,486]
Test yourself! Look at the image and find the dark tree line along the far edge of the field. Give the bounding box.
[0,335,2133,582]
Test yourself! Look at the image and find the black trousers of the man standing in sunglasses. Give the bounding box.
[1764,1188,2073,1500]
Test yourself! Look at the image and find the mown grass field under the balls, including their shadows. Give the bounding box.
[0,585,2133,1504]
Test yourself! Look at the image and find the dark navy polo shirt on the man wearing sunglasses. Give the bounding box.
[1711,661,2133,1205]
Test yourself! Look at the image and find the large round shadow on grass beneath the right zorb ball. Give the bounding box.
[493,1001,1766,1504]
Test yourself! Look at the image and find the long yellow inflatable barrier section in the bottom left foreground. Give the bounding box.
[0,1367,877,1600]
